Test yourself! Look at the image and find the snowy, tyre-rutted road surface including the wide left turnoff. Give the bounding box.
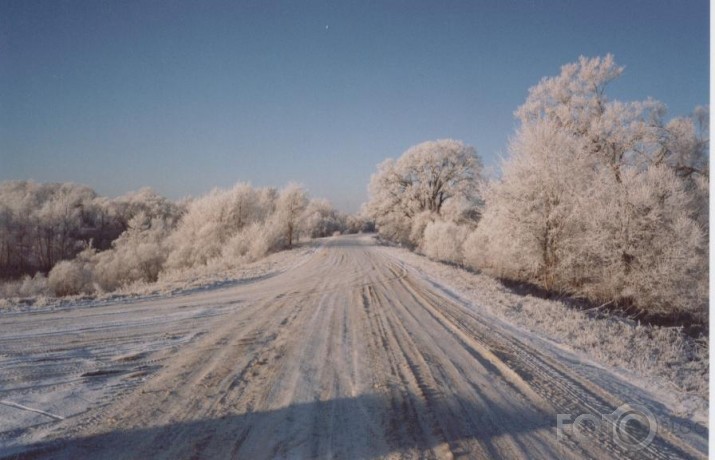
[0,236,707,459]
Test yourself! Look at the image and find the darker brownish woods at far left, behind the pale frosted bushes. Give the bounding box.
[0,181,181,279]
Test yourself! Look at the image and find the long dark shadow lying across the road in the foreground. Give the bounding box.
[0,395,555,459]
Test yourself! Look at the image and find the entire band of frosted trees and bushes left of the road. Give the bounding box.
[0,181,370,297]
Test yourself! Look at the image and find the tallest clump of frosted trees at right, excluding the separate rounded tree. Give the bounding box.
[465,55,708,311]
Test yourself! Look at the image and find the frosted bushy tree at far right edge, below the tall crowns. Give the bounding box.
[580,165,708,313]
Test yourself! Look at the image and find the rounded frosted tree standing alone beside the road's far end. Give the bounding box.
[367,139,482,246]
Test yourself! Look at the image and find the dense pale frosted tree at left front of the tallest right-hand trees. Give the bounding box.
[467,121,594,288]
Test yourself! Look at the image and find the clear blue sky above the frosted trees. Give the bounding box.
[0,0,709,211]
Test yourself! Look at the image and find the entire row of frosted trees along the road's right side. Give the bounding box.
[364,55,709,315]
